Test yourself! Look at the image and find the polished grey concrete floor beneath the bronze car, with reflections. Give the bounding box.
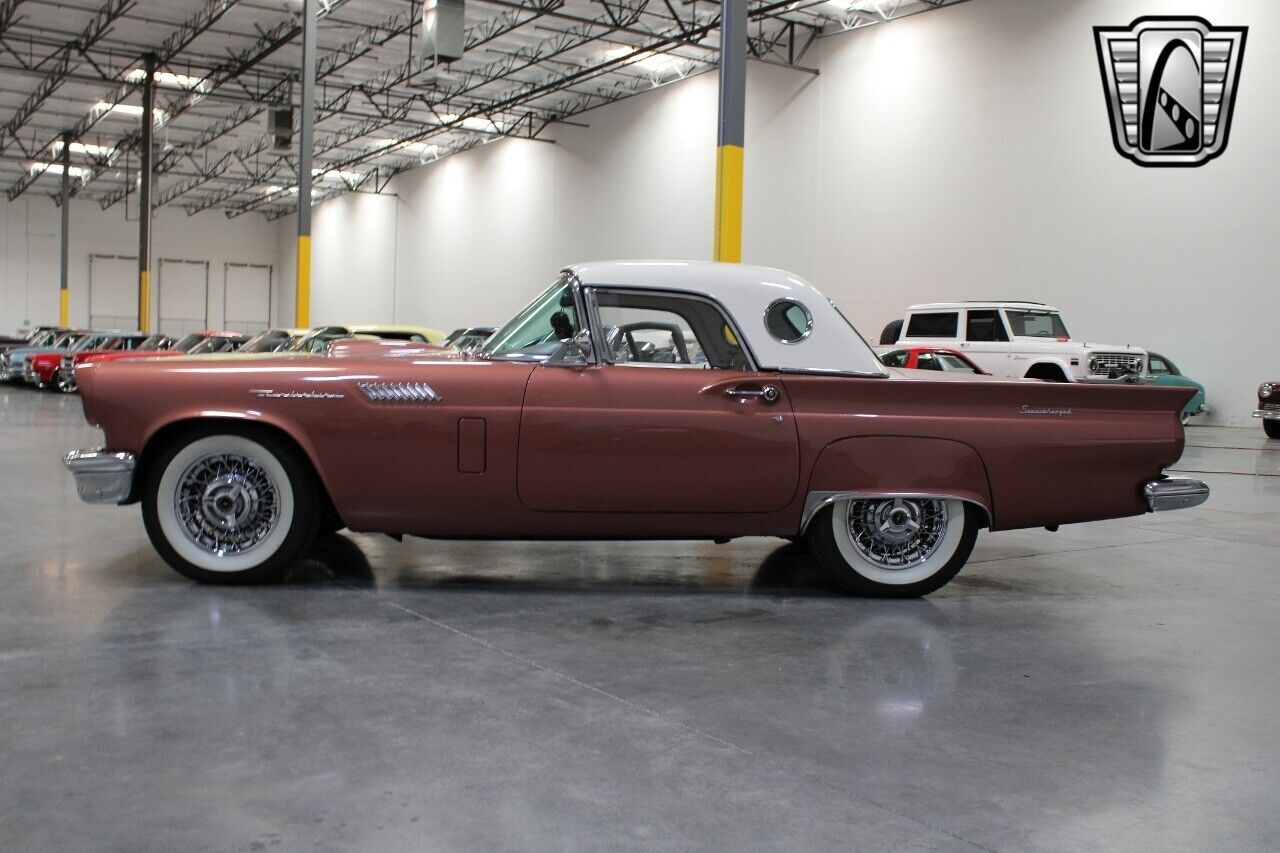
[0,388,1280,850]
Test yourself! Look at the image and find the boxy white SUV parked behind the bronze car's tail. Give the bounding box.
[881,302,1149,382]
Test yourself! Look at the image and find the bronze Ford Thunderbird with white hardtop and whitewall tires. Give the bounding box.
[67,263,1208,596]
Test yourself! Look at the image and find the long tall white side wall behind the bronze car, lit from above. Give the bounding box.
[291,0,1249,424]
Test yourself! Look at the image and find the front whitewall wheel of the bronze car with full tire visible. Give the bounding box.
[142,427,321,584]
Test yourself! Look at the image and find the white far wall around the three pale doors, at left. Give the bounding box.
[0,192,284,334]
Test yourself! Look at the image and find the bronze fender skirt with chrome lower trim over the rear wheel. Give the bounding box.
[800,435,996,533]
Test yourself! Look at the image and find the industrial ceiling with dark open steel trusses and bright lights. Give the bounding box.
[0,0,963,218]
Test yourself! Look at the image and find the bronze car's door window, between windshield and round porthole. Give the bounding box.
[594,289,750,370]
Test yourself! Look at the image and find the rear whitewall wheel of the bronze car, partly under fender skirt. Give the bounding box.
[809,497,978,598]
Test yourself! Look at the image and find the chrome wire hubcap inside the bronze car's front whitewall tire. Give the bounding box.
[174,453,280,556]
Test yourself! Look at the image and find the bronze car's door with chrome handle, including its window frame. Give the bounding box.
[517,288,800,512]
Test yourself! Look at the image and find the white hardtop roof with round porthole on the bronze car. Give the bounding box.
[566,260,888,377]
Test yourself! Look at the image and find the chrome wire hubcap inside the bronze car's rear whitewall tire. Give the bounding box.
[847,498,947,570]
